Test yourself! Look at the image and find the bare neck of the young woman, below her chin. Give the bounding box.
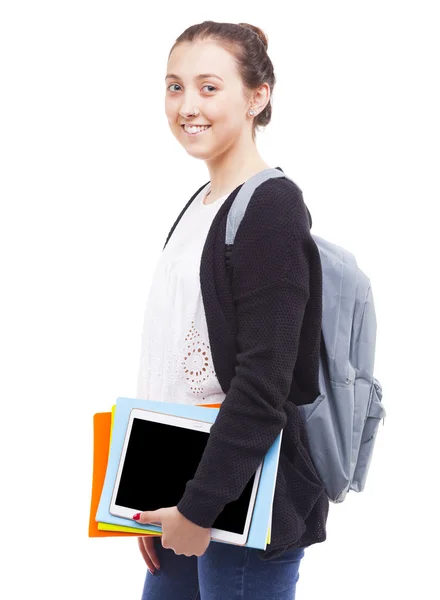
[205,130,270,198]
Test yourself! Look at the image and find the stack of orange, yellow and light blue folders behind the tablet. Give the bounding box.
[89,398,283,550]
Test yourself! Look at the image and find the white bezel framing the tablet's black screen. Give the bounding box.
[109,408,263,546]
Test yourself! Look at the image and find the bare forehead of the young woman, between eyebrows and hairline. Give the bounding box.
[167,40,238,81]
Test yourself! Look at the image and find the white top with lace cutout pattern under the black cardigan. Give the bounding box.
[136,183,229,404]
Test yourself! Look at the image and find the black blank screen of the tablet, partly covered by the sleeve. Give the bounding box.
[116,418,255,534]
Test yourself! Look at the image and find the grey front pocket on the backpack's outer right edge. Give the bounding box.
[350,377,386,492]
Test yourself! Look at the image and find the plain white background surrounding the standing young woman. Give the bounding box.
[0,0,440,600]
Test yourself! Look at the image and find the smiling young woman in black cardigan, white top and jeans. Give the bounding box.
[134,21,329,600]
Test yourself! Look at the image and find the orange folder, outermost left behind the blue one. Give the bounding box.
[89,404,221,537]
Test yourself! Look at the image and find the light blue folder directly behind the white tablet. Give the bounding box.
[95,398,282,550]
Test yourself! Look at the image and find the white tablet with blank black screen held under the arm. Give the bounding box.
[110,408,263,546]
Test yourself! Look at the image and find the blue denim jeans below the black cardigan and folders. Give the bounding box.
[141,537,305,600]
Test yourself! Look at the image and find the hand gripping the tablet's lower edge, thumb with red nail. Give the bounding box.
[133,506,211,556]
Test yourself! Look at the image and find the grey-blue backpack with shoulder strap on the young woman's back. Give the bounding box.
[225,169,386,503]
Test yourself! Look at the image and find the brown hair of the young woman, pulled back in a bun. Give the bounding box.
[168,21,276,141]
